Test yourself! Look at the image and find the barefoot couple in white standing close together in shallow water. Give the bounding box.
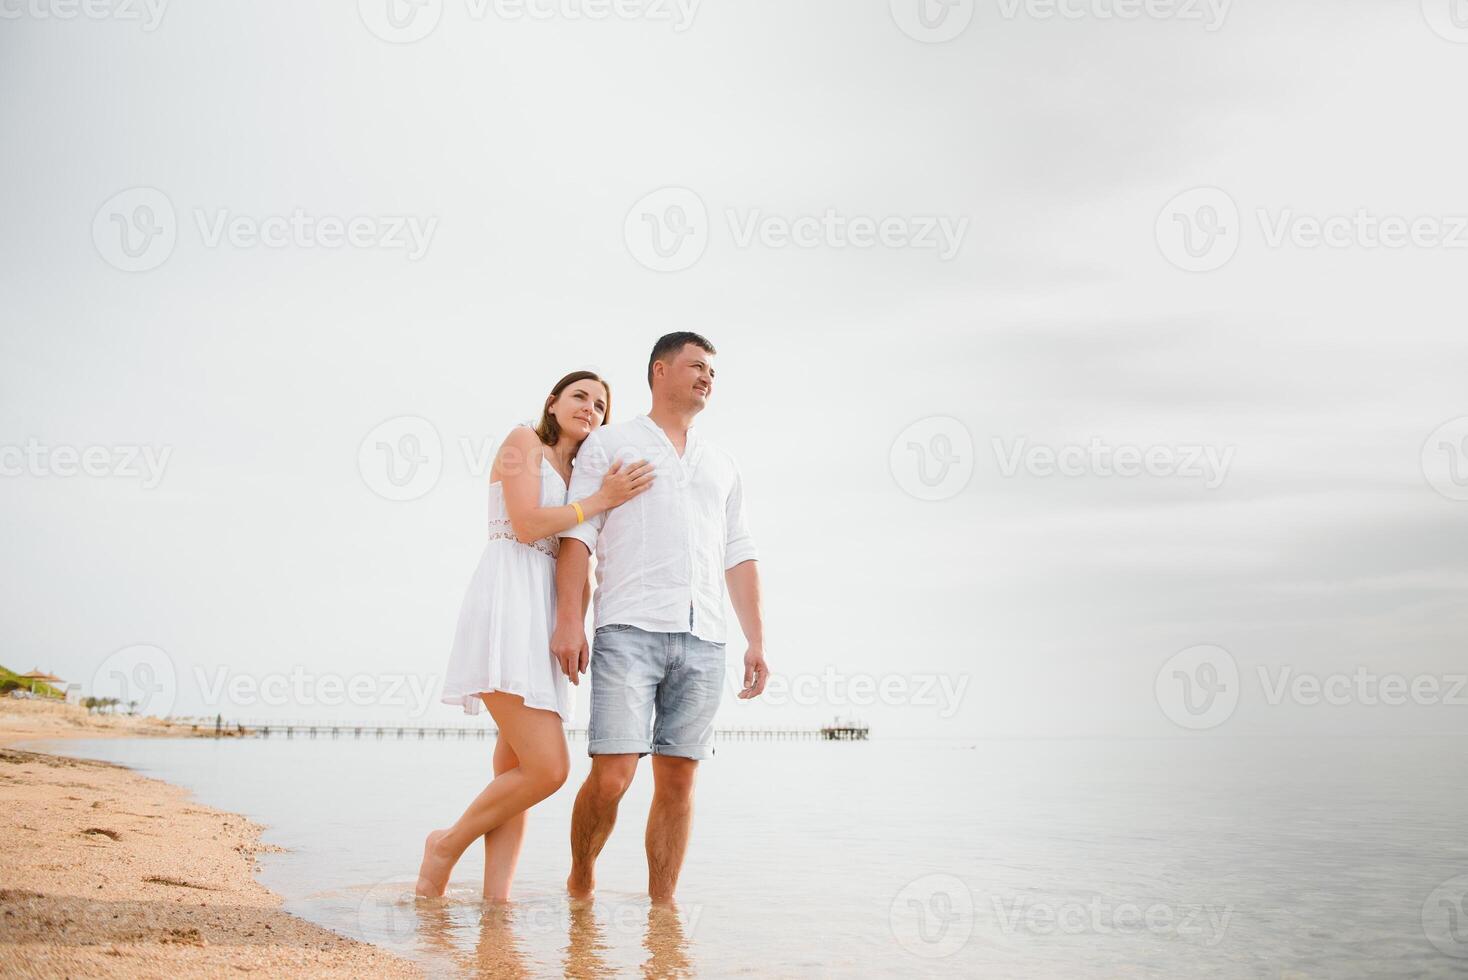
[415,333,768,905]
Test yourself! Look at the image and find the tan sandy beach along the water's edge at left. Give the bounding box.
[0,698,421,977]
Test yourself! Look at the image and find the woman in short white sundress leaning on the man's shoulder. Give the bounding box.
[415,371,652,902]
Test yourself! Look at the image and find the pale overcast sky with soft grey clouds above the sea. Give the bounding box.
[0,0,1468,736]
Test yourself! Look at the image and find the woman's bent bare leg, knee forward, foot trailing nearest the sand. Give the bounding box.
[414,691,571,896]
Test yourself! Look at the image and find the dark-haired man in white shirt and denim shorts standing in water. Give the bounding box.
[551,333,769,905]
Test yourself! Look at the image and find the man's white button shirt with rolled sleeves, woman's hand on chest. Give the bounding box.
[561,415,759,643]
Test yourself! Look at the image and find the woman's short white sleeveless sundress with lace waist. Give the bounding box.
[442,458,574,722]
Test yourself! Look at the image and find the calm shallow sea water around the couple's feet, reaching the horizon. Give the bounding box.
[31,736,1468,977]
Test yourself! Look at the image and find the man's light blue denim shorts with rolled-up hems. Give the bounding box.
[587,624,724,758]
